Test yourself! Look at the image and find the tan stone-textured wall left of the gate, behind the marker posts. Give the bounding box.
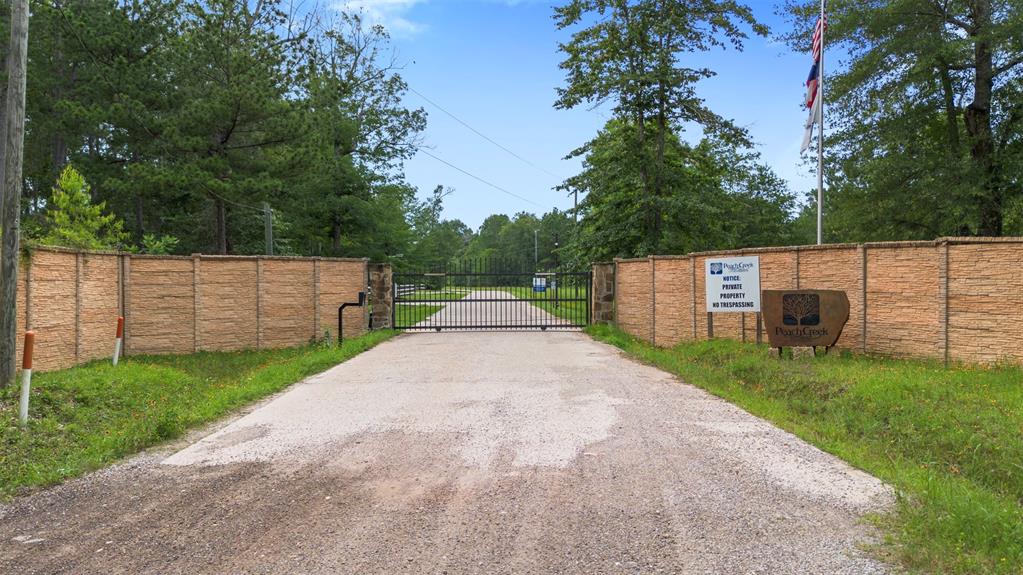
[9,249,368,370]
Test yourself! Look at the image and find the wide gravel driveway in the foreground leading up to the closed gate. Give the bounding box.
[0,331,891,574]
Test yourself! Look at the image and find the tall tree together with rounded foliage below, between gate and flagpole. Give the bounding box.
[554,0,794,260]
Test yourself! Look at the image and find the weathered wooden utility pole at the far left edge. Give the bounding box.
[0,0,29,387]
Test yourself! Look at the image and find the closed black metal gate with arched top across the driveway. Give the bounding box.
[391,259,591,331]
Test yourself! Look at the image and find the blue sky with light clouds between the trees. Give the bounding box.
[340,0,815,228]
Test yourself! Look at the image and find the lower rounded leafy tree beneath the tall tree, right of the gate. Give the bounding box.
[566,120,795,262]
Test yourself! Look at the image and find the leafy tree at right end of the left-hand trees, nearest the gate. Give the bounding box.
[291,15,426,255]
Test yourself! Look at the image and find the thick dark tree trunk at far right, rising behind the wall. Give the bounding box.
[964,0,1003,236]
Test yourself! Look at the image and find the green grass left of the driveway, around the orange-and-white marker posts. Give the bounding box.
[0,330,396,500]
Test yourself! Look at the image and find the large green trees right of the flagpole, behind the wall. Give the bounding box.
[784,0,1023,240]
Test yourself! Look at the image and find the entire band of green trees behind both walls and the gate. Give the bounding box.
[2,0,1023,267]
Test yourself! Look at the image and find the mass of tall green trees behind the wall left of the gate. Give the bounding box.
[23,0,426,258]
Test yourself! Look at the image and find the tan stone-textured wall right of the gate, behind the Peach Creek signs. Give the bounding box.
[614,237,1023,363]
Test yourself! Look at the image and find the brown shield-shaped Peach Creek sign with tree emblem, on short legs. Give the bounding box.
[763,290,849,348]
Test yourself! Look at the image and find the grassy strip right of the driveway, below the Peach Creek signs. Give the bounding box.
[587,325,1023,573]
